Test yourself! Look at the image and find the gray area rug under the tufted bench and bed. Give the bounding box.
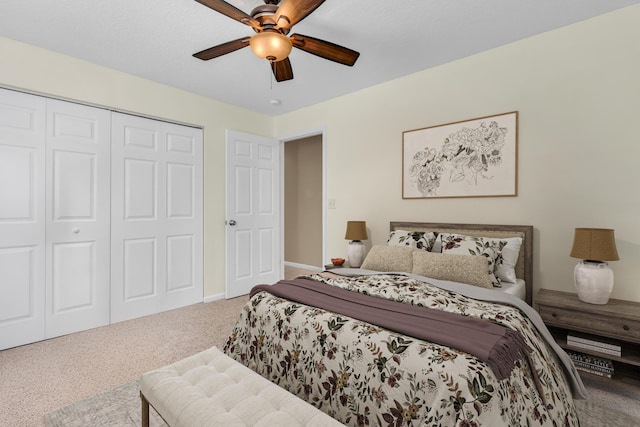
[44,381,640,427]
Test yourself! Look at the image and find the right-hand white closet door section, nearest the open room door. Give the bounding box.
[111,113,203,322]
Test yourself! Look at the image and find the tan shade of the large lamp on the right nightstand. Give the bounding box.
[570,228,620,261]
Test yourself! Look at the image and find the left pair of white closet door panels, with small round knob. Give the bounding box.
[0,90,111,349]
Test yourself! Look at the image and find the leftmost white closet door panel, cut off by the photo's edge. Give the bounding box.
[0,89,45,350]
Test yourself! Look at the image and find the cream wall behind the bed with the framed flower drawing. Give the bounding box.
[275,6,640,301]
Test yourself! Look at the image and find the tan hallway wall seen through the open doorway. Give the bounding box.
[284,135,323,267]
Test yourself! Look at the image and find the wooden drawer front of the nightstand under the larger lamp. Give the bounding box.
[539,305,640,342]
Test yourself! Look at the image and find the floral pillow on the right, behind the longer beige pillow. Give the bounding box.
[442,233,507,288]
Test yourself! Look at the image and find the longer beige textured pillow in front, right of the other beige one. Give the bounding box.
[413,251,493,288]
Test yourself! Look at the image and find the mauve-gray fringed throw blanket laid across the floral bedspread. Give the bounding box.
[251,279,532,380]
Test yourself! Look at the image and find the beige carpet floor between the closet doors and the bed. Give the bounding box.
[0,297,247,427]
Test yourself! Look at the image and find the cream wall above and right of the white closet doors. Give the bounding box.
[0,37,272,297]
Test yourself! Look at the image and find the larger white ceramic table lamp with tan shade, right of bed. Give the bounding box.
[570,228,620,304]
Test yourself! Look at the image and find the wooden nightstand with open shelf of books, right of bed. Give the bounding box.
[534,289,640,387]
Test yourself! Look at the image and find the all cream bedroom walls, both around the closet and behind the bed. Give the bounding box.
[0,5,640,301]
